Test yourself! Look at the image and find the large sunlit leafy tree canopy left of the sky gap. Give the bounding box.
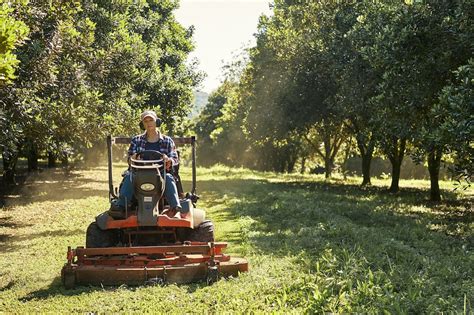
[0,0,200,181]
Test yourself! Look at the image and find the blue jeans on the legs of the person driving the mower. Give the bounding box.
[112,171,181,208]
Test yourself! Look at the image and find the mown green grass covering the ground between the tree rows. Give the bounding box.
[0,164,474,314]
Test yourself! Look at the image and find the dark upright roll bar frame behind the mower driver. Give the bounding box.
[107,136,196,198]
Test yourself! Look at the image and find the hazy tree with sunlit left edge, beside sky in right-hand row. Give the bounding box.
[242,1,345,177]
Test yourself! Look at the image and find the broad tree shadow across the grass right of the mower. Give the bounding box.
[188,179,474,311]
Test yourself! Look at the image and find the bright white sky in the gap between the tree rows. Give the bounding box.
[175,0,271,93]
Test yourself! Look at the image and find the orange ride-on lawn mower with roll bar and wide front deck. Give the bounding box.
[61,136,248,288]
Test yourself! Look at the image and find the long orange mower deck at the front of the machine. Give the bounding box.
[61,242,248,288]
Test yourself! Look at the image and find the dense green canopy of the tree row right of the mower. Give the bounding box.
[194,0,474,200]
